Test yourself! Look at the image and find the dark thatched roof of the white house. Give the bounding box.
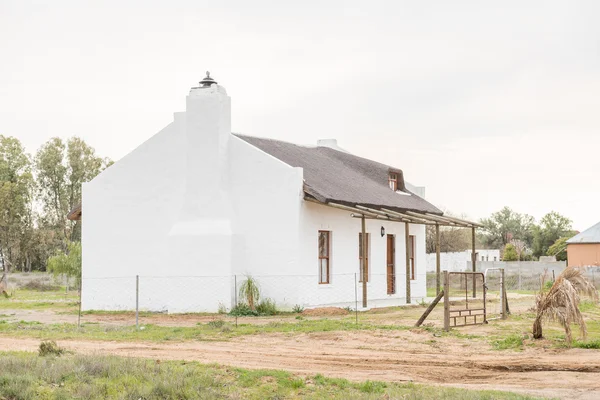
[236,134,442,215]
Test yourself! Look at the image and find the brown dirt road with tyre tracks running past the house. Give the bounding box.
[0,331,600,400]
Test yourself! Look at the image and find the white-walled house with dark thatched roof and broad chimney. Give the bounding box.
[77,76,468,312]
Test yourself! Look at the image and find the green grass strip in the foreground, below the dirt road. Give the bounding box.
[0,353,548,400]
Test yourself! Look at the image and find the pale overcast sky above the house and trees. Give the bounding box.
[0,0,600,230]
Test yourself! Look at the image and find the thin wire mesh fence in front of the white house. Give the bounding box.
[81,273,427,324]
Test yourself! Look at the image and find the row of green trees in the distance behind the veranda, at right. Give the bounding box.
[426,207,577,261]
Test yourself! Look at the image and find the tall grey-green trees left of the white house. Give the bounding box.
[0,135,112,272]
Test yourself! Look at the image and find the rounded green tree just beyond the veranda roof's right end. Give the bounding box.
[481,207,535,249]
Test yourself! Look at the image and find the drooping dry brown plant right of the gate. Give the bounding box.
[533,267,598,343]
